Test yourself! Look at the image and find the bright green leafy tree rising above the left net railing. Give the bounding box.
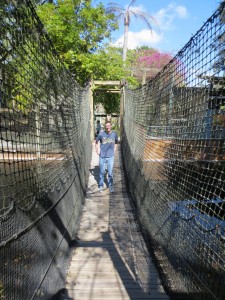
[37,0,117,84]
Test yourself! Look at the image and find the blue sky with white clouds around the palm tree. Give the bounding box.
[93,0,220,55]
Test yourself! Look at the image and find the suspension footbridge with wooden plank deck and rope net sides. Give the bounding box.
[0,0,225,300]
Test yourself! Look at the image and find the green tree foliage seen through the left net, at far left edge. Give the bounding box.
[0,1,39,110]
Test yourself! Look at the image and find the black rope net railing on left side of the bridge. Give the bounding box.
[0,0,91,300]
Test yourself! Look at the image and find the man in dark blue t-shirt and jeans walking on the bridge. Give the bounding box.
[95,121,118,193]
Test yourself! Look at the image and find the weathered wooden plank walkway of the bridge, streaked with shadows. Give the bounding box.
[63,144,169,300]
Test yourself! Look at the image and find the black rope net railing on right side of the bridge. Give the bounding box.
[121,2,225,300]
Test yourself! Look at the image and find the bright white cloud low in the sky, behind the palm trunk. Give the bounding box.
[114,29,163,49]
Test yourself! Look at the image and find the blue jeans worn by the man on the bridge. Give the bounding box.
[99,156,114,188]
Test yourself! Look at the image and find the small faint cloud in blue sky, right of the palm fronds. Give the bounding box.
[154,3,188,30]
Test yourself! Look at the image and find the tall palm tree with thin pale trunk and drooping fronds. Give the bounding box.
[108,0,157,62]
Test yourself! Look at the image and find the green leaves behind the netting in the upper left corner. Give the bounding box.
[0,3,42,112]
